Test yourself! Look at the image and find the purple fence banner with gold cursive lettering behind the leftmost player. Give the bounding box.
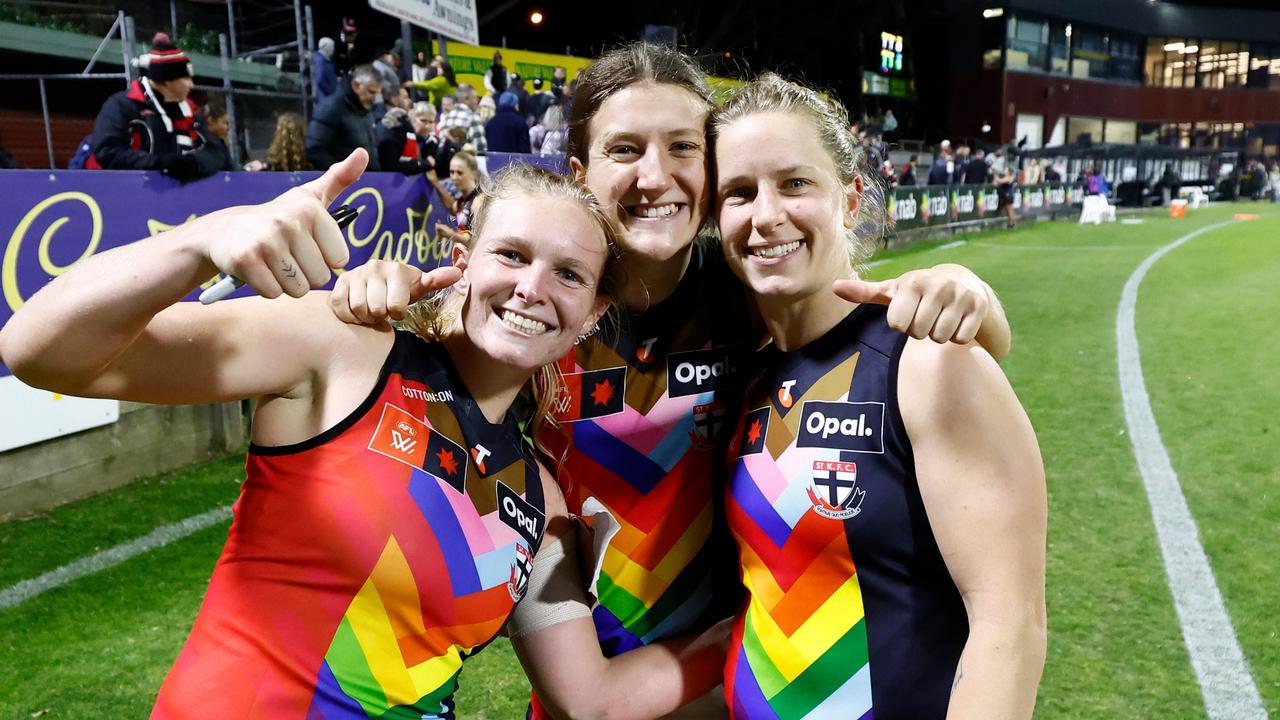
[0,152,567,377]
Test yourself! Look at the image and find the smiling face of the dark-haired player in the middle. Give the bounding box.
[570,83,709,261]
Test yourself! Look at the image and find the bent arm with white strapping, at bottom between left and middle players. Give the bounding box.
[508,470,730,720]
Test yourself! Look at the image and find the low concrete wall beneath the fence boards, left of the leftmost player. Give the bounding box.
[0,402,246,520]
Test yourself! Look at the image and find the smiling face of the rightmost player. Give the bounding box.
[716,111,858,309]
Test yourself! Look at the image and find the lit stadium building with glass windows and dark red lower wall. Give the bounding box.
[947,0,1280,156]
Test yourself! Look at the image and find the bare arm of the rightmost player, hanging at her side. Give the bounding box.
[899,341,1047,719]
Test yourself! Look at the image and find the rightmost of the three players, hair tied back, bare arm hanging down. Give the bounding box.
[710,73,1047,720]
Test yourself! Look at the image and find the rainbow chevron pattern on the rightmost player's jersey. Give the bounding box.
[724,368,872,720]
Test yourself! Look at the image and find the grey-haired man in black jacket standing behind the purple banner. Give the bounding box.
[307,65,383,170]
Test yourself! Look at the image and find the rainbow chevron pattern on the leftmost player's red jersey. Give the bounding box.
[308,470,529,720]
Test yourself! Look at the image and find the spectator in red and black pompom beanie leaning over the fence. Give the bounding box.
[84,32,228,182]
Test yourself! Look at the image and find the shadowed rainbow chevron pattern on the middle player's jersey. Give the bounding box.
[564,347,716,656]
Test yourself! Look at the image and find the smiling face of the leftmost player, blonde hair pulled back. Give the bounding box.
[456,192,608,373]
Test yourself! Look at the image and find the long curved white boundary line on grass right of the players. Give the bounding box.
[1116,220,1267,720]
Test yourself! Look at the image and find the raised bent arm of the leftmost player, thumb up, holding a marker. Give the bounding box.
[0,151,365,402]
